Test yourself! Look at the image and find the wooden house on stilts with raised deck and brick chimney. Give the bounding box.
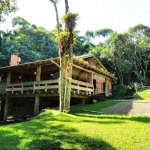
[0,54,116,121]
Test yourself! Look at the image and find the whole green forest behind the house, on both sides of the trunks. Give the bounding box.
[0,17,150,85]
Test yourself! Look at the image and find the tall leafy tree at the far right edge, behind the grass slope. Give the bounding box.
[128,24,150,80]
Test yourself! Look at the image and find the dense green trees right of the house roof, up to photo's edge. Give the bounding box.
[87,24,150,84]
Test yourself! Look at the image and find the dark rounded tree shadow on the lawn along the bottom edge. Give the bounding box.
[26,133,115,150]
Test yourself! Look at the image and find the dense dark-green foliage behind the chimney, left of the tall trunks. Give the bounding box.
[0,17,58,66]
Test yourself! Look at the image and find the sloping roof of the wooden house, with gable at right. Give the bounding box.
[0,54,117,80]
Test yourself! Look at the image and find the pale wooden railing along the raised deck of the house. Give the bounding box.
[0,79,94,95]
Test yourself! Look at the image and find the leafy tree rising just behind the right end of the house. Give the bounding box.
[101,33,131,84]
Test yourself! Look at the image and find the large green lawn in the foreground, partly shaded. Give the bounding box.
[0,101,150,150]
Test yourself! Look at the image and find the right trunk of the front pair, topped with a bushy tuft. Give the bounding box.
[61,12,78,112]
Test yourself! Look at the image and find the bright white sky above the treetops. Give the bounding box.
[0,0,150,34]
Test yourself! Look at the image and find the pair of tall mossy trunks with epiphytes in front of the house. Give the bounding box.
[50,0,78,112]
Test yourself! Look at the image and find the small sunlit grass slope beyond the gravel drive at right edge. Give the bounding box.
[134,88,150,100]
